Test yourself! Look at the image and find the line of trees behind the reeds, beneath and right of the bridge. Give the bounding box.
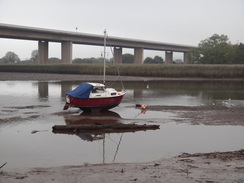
[0,34,244,64]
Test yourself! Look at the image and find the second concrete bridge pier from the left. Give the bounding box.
[61,41,72,64]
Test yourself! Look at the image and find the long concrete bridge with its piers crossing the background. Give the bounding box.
[0,24,193,64]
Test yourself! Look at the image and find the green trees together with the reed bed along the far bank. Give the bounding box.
[0,34,244,79]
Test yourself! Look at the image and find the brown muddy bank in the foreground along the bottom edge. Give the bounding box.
[0,150,244,183]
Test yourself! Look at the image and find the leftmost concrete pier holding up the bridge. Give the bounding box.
[38,41,48,64]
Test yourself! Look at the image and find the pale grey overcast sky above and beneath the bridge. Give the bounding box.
[0,0,244,60]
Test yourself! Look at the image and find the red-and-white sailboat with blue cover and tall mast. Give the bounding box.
[63,30,126,111]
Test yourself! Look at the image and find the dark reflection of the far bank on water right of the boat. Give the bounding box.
[125,81,244,100]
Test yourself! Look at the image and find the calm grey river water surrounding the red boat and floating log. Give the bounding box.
[0,81,244,168]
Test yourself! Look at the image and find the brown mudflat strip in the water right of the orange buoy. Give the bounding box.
[147,105,244,126]
